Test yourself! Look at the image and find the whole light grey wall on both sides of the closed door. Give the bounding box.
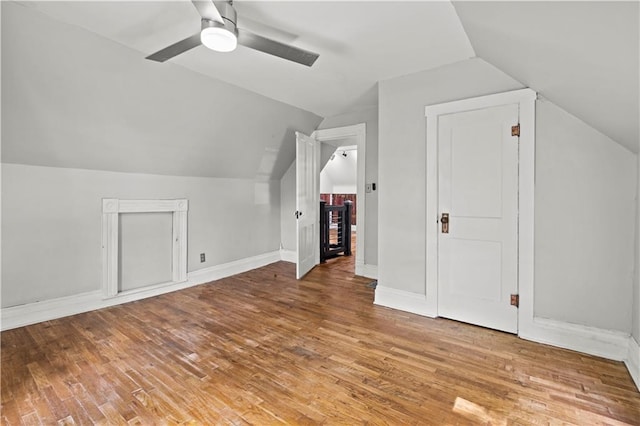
[378,59,636,332]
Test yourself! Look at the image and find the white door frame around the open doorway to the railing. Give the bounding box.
[311,123,367,275]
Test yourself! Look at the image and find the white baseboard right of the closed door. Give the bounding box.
[518,318,629,361]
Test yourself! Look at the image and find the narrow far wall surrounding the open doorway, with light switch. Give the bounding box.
[280,108,378,265]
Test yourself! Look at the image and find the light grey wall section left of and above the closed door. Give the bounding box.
[378,59,522,295]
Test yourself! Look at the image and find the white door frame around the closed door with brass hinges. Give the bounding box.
[425,89,537,334]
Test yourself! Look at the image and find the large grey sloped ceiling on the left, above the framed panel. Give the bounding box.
[2,2,321,180]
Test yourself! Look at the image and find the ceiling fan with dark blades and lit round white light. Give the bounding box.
[146,0,320,67]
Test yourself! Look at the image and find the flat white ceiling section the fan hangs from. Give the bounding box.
[17,0,474,117]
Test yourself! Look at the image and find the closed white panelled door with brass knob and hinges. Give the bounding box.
[438,104,518,333]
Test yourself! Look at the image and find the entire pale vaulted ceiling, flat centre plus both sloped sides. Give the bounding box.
[2,0,640,179]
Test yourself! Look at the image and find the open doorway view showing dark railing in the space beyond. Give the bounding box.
[319,143,358,272]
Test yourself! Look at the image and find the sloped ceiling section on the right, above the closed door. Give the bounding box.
[454,1,640,152]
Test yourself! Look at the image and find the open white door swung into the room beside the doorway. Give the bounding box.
[295,132,320,279]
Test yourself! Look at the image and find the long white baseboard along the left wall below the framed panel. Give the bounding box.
[0,251,280,331]
